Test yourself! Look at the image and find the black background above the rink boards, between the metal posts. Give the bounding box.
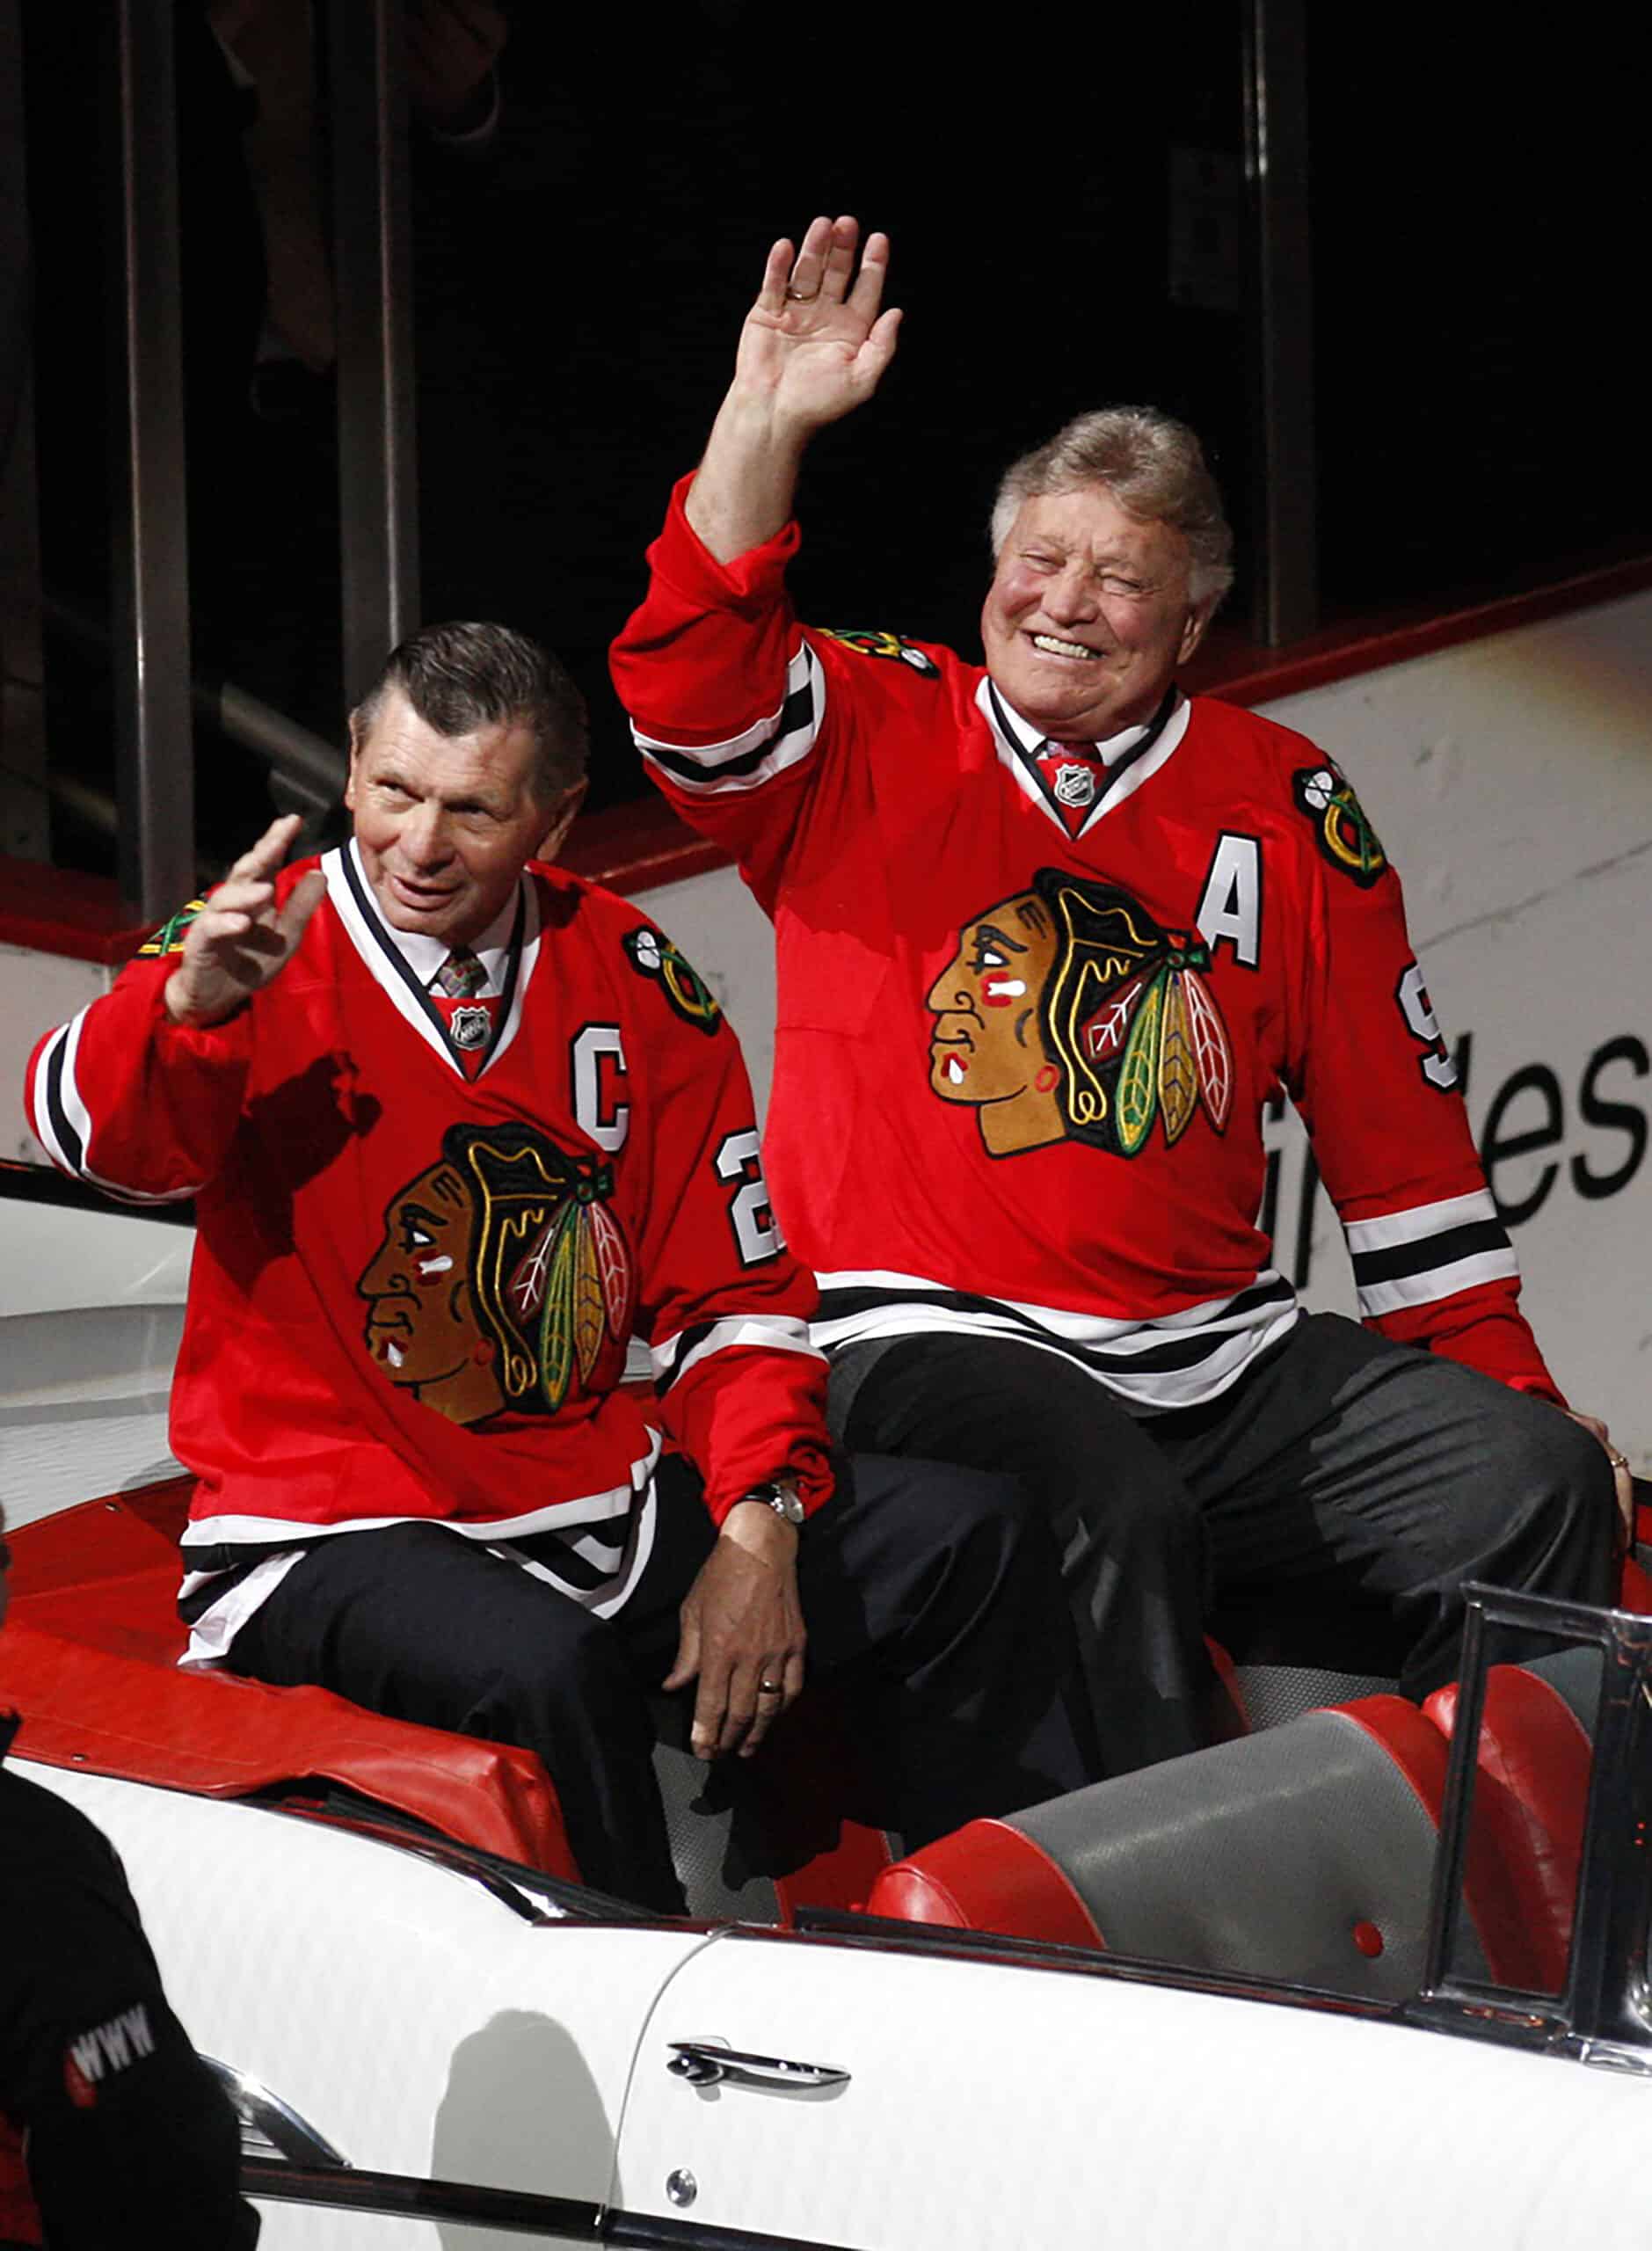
[25,0,1648,869]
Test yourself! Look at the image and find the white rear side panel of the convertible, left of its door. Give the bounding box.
[16,1760,707,2251]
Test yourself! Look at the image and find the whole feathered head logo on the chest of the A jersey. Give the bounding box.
[928,867,1234,1157]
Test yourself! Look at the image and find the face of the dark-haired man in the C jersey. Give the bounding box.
[345,688,586,945]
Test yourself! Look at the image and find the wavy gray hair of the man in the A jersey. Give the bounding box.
[993,407,1234,608]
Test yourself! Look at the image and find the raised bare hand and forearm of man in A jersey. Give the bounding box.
[688,218,900,563]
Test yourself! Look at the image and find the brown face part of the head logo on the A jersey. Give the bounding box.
[925,892,1062,1155]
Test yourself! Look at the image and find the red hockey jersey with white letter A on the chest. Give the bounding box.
[615,484,1557,1414]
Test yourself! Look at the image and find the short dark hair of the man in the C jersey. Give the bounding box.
[349,623,587,804]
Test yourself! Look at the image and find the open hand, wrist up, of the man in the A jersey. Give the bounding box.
[734,218,900,433]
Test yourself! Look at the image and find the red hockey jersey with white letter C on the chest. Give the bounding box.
[27,847,831,1612]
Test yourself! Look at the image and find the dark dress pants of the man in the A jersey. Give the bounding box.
[831,1315,1616,1774]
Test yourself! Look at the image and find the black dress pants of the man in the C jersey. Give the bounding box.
[229,1459,1101,1913]
